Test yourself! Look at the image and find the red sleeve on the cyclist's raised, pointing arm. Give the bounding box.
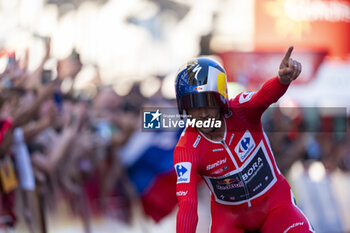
[230,77,289,123]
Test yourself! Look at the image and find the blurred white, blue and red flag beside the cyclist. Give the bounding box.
[119,131,181,222]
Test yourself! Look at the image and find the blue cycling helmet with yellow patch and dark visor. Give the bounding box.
[175,57,228,115]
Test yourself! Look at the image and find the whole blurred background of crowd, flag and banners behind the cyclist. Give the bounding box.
[0,0,350,233]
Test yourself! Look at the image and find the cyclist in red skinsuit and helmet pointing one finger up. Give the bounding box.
[174,47,314,233]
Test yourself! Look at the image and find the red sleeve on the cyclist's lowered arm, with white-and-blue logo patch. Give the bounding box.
[174,146,199,233]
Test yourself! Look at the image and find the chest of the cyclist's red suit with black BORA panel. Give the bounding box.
[199,127,277,205]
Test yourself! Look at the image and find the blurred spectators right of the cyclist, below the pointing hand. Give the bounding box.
[263,107,350,175]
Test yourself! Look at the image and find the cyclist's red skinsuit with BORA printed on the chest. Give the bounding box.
[174,77,313,233]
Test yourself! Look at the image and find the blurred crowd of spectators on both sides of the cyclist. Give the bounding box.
[0,36,350,232]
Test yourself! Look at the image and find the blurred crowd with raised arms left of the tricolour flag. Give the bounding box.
[0,39,146,232]
